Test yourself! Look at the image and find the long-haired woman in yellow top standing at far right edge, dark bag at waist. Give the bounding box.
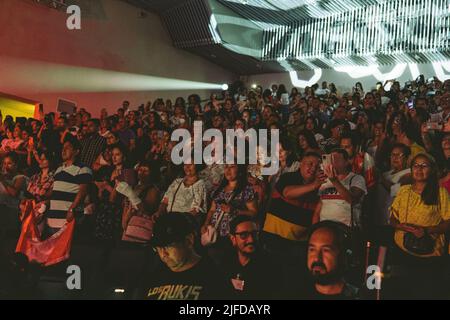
[390,154,450,299]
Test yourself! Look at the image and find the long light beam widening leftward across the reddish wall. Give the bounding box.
[0,57,224,93]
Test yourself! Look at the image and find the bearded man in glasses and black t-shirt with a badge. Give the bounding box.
[225,215,283,300]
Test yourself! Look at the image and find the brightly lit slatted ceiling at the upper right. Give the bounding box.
[123,0,450,75]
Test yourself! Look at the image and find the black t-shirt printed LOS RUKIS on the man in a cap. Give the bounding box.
[136,258,230,300]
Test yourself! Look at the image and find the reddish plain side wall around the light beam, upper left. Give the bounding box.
[0,0,234,115]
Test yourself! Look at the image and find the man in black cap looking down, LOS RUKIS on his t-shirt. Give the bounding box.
[137,213,229,300]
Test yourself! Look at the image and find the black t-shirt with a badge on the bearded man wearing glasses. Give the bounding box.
[225,252,284,300]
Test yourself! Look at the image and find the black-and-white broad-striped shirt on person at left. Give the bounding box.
[47,163,92,228]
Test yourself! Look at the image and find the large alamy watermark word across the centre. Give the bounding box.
[171,121,280,175]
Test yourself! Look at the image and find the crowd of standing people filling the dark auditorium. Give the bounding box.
[0,76,450,300]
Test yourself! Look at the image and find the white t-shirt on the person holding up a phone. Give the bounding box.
[319,172,367,226]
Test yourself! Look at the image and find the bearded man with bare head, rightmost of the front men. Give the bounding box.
[302,221,358,300]
